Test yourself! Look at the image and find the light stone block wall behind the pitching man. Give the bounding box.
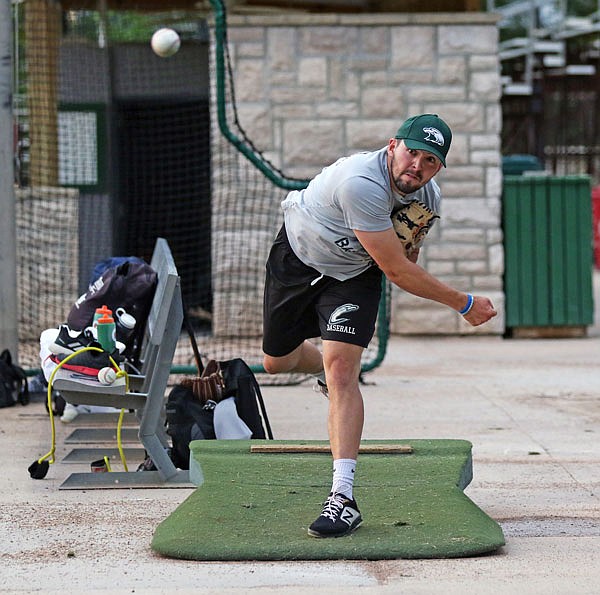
[213,13,504,334]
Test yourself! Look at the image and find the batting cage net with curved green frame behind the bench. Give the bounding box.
[13,0,389,382]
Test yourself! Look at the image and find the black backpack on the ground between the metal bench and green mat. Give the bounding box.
[166,358,273,469]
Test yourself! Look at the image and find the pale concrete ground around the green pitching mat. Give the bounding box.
[0,275,600,595]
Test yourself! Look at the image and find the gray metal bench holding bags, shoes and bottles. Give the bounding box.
[54,238,193,489]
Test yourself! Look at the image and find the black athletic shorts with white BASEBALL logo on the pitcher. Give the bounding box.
[263,227,382,357]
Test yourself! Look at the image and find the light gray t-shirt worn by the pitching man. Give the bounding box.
[281,147,441,281]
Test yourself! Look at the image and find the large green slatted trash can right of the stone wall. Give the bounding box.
[502,176,594,336]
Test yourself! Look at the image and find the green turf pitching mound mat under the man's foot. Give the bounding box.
[152,440,504,561]
